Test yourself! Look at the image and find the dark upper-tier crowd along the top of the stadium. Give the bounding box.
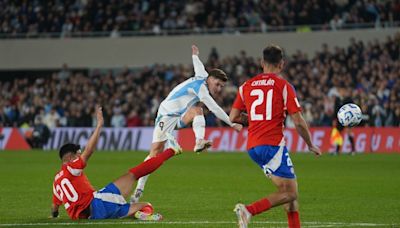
[0,0,400,37]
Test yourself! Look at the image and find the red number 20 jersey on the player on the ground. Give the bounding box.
[53,156,95,219]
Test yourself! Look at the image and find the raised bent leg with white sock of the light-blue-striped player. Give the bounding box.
[182,106,212,152]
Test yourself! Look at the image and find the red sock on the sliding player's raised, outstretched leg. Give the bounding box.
[129,149,175,180]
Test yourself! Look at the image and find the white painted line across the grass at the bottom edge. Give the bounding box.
[0,221,400,228]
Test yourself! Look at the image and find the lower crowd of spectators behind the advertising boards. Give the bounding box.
[0,34,400,128]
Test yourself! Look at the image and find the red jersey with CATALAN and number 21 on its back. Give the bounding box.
[233,74,301,149]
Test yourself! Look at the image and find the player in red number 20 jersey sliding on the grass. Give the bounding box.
[51,107,182,221]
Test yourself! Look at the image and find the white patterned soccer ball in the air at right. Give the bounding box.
[337,103,362,127]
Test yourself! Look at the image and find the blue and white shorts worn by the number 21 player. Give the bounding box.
[249,146,296,179]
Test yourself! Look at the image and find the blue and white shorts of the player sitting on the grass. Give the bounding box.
[90,183,131,219]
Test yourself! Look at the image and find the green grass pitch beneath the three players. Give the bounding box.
[0,151,400,228]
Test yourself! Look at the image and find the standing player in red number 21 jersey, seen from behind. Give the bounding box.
[230,45,321,228]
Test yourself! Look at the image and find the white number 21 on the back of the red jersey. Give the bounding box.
[250,89,274,121]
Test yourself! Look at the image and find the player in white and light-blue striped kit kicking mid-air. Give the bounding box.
[131,45,243,202]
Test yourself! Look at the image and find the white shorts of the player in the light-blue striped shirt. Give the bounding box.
[152,116,186,143]
